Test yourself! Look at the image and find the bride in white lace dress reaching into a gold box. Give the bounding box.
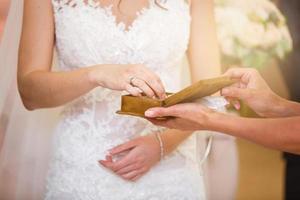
[0,0,230,200]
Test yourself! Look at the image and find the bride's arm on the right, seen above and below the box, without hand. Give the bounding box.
[162,0,221,153]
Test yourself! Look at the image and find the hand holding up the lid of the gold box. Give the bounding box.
[221,68,286,117]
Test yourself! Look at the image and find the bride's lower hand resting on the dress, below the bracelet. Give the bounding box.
[99,134,161,181]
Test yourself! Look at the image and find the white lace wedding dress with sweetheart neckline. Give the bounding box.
[45,0,205,200]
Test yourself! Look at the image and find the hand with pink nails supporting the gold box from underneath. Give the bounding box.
[145,103,215,131]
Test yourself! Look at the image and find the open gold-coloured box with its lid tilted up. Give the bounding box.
[117,76,236,117]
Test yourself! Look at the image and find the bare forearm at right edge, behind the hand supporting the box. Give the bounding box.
[208,113,300,154]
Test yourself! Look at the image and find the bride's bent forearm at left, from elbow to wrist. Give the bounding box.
[18,67,97,110]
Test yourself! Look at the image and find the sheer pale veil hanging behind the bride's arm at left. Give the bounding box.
[0,0,59,200]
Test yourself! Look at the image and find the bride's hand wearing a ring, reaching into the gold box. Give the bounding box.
[89,64,166,99]
